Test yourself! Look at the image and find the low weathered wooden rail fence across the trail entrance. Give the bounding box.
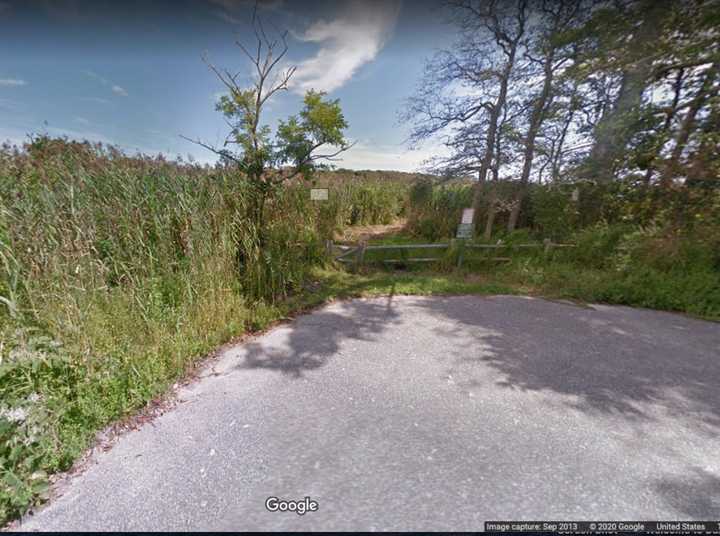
[326,238,575,269]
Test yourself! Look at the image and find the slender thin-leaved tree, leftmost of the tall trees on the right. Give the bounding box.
[400,0,531,236]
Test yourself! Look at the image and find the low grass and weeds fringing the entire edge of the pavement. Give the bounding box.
[5,251,720,528]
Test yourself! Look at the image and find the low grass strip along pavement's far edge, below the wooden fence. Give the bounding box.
[308,259,720,321]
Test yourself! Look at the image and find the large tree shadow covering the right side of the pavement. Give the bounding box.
[417,296,720,431]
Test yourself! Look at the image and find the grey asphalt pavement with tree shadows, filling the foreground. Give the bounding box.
[19,296,720,531]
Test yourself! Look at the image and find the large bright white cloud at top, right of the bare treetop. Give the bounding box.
[292,0,400,93]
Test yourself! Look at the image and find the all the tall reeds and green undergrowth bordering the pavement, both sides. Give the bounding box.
[0,137,720,519]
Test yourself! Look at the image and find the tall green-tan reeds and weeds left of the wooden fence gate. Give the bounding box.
[0,137,406,519]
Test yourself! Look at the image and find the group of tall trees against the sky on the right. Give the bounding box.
[402,0,720,234]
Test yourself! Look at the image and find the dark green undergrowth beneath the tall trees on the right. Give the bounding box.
[400,181,720,318]
